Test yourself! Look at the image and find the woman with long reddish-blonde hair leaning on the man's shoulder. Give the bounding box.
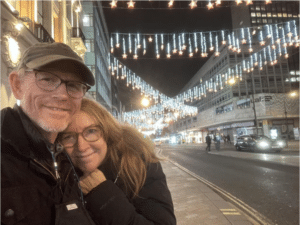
[58,99,176,225]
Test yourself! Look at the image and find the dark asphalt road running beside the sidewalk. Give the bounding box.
[160,146,299,225]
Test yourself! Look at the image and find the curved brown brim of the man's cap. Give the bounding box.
[26,55,95,86]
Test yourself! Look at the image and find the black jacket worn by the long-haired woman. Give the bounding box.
[85,159,176,225]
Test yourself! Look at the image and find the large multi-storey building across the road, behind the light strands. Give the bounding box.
[170,1,300,142]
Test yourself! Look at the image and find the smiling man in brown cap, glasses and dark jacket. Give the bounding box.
[1,43,95,224]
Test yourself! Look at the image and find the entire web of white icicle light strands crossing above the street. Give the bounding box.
[113,21,299,128]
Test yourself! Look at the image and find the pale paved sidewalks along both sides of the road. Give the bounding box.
[158,142,299,225]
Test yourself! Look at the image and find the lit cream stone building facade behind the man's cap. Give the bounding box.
[1,0,86,109]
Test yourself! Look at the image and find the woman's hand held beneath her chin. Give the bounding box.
[79,169,106,195]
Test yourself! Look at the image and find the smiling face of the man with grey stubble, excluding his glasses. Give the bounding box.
[20,70,82,133]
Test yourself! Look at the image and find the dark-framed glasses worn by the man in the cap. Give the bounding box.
[27,70,91,98]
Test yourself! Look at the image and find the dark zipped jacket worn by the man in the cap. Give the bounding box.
[1,106,80,225]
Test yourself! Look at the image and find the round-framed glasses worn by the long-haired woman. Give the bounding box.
[58,126,102,148]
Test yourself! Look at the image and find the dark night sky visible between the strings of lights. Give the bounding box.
[102,1,232,111]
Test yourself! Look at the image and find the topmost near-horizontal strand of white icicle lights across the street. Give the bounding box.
[110,20,299,59]
